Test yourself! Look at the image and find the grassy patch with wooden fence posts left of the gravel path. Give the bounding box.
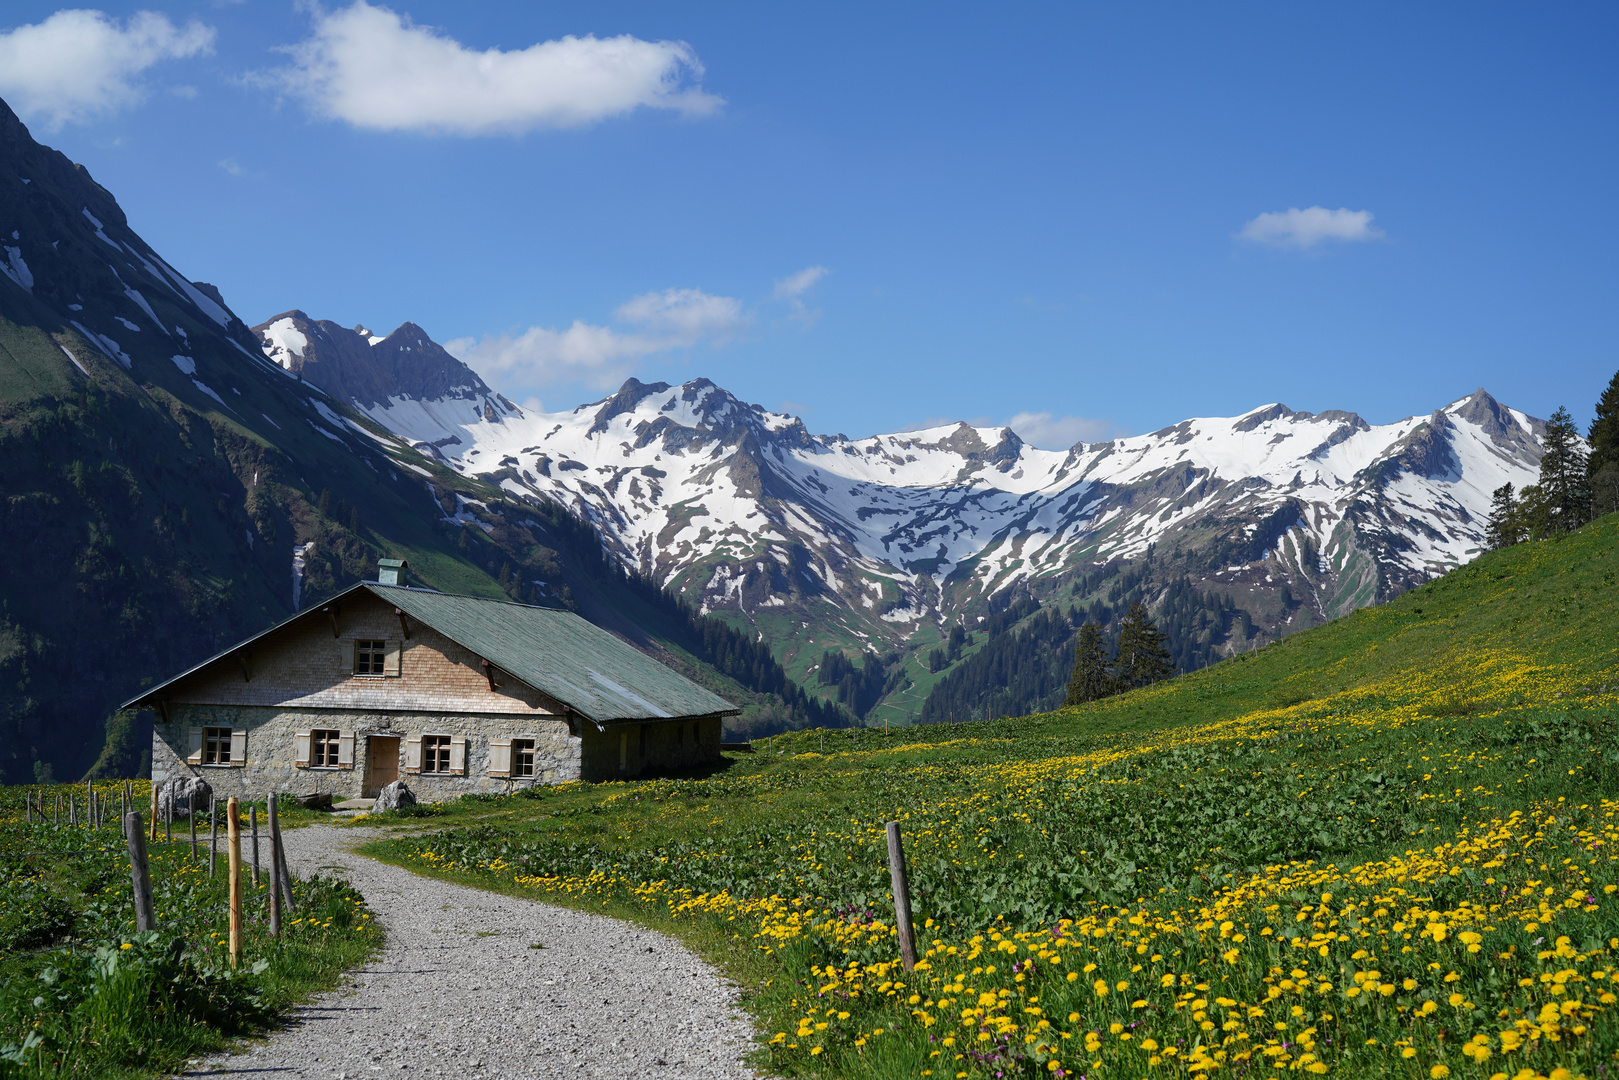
[0,780,382,1077]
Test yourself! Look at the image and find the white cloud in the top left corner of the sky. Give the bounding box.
[0,10,214,131]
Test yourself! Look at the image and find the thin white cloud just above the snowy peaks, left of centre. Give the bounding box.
[445,288,746,390]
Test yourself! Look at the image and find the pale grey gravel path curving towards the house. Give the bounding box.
[186,826,756,1080]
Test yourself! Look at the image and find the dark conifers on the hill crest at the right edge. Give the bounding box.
[1486,372,1619,551]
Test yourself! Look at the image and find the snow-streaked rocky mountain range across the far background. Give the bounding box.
[261,324,1543,689]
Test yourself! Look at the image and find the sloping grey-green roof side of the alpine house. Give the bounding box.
[370,581,740,724]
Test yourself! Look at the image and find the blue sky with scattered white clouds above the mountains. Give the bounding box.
[0,0,1619,447]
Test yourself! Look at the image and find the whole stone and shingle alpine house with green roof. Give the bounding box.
[125,563,738,801]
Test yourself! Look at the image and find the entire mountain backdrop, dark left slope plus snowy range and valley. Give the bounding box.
[0,88,1543,782]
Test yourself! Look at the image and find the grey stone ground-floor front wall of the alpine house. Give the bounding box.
[152,704,582,801]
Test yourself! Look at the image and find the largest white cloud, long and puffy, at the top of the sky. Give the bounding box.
[257,0,720,136]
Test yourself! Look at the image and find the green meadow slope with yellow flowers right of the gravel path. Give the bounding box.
[367,515,1619,1077]
